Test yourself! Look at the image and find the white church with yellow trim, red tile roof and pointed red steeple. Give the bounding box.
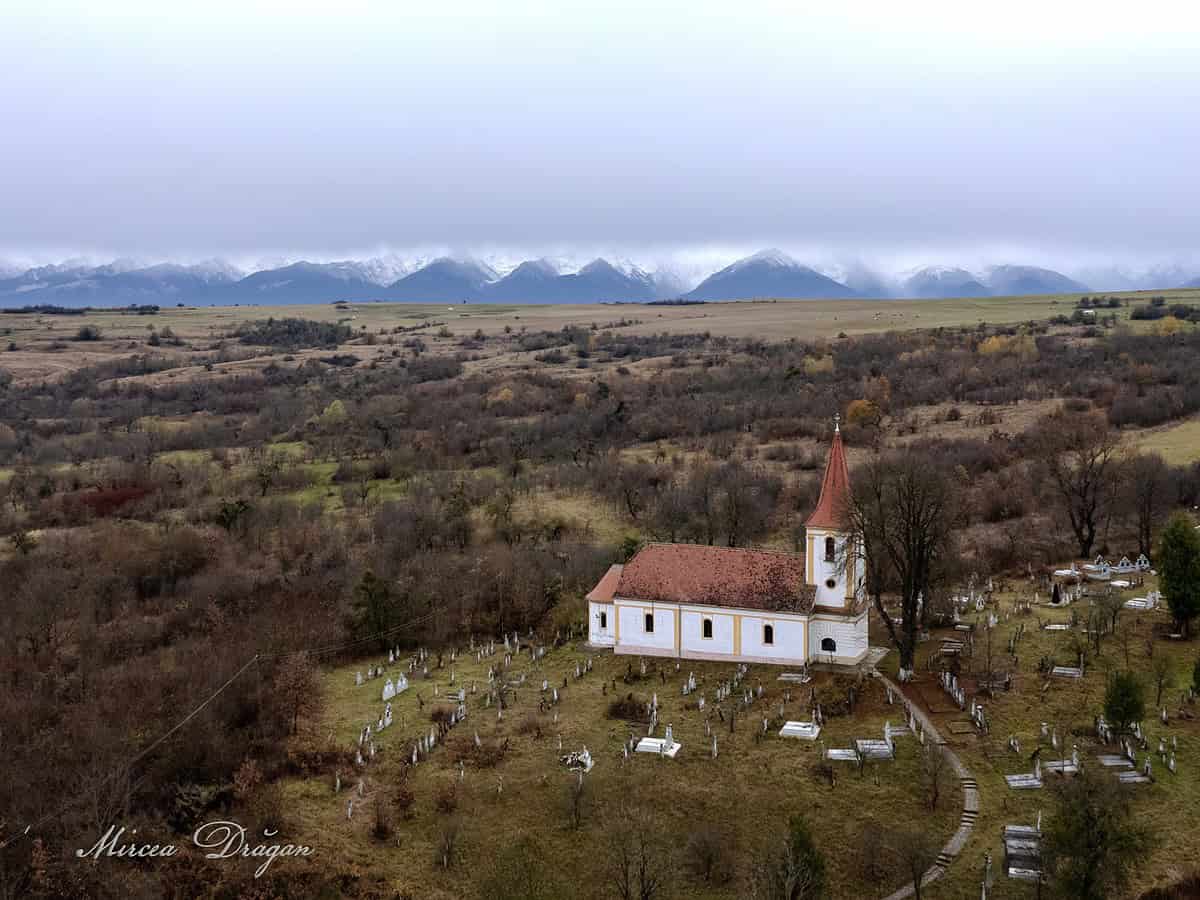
[587,425,869,666]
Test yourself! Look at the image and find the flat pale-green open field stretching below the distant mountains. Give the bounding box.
[0,289,1200,380]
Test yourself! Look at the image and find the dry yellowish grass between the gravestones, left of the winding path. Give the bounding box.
[278,647,960,898]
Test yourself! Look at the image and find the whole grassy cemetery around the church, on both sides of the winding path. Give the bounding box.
[267,561,1200,898]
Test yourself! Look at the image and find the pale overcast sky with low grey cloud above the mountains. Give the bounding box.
[0,0,1200,271]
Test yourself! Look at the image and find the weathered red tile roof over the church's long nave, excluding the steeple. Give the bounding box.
[609,544,814,612]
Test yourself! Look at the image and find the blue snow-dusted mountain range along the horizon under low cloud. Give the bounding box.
[0,250,1200,307]
